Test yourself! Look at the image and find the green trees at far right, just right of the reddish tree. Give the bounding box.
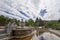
[45,20,60,29]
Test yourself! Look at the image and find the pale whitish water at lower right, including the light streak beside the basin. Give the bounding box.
[31,31,60,40]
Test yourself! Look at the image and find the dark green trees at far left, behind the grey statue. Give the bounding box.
[0,15,19,26]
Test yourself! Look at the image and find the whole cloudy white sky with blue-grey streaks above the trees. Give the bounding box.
[0,0,60,20]
